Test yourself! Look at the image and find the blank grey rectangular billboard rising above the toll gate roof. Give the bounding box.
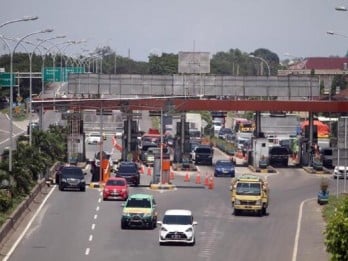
[178,52,210,74]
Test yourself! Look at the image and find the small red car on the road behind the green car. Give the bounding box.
[103,177,129,200]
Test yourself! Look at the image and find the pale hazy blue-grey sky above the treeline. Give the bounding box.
[0,0,348,61]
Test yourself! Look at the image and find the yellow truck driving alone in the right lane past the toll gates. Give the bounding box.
[231,174,269,216]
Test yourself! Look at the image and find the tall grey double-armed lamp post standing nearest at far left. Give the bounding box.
[1,29,53,172]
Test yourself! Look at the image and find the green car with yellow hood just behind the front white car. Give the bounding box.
[121,194,157,229]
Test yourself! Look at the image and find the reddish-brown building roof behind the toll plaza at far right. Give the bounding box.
[289,57,348,70]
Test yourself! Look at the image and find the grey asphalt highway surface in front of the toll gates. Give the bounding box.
[0,109,341,261]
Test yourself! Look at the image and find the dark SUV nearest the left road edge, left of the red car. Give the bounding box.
[59,166,86,191]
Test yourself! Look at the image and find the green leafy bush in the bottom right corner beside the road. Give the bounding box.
[325,196,348,261]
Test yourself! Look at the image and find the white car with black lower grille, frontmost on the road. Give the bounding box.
[157,209,198,245]
